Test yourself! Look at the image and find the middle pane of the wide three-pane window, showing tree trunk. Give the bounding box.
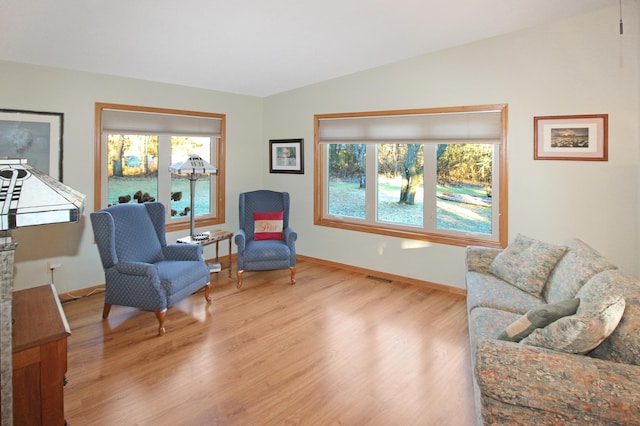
[377,144,424,227]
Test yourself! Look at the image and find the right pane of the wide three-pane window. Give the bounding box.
[436,144,493,235]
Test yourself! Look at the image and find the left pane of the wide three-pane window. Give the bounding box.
[328,144,366,219]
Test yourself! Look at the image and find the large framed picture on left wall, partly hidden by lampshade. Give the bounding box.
[0,109,64,181]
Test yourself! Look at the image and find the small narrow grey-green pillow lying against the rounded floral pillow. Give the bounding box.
[498,299,580,342]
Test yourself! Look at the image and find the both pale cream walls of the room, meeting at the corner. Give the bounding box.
[0,1,640,292]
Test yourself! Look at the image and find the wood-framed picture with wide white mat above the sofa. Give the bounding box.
[533,114,608,161]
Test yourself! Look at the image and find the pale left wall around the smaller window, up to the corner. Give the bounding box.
[0,61,262,293]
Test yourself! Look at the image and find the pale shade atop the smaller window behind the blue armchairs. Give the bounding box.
[102,109,222,137]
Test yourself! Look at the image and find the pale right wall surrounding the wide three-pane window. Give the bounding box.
[264,2,640,288]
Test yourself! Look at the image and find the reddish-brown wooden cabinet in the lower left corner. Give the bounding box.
[12,285,71,425]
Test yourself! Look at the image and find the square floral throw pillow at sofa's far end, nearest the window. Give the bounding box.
[489,234,567,296]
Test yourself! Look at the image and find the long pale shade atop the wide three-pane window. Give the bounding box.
[319,111,502,144]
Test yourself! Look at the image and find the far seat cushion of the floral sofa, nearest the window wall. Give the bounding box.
[466,272,544,314]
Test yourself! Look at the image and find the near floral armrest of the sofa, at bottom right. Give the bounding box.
[474,340,640,425]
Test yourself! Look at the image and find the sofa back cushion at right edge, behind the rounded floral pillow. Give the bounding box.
[577,269,640,365]
